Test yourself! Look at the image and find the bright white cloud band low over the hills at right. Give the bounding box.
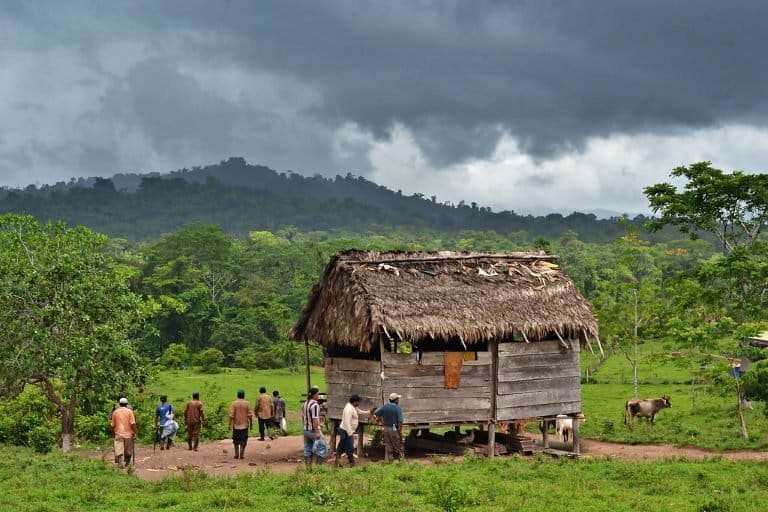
[334,124,768,214]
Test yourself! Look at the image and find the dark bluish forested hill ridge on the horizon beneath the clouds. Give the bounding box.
[0,158,665,242]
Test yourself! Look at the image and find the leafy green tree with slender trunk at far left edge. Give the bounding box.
[0,215,152,451]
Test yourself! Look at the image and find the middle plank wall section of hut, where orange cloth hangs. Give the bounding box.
[383,352,491,425]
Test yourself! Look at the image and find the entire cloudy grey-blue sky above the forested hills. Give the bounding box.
[0,0,768,212]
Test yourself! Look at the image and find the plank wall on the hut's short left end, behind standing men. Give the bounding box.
[325,357,381,419]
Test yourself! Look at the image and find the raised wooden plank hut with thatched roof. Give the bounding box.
[291,251,598,454]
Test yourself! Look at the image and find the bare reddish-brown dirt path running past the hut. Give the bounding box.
[88,434,768,480]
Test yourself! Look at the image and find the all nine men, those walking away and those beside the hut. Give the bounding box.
[110,386,405,468]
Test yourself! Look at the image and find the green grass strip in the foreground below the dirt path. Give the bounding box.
[0,446,768,512]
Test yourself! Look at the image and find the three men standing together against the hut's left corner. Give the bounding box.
[301,386,405,467]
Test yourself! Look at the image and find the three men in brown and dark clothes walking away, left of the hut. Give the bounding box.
[229,386,287,459]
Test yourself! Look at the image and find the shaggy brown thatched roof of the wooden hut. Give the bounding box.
[291,251,598,352]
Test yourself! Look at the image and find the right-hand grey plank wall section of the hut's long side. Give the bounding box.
[496,340,581,421]
